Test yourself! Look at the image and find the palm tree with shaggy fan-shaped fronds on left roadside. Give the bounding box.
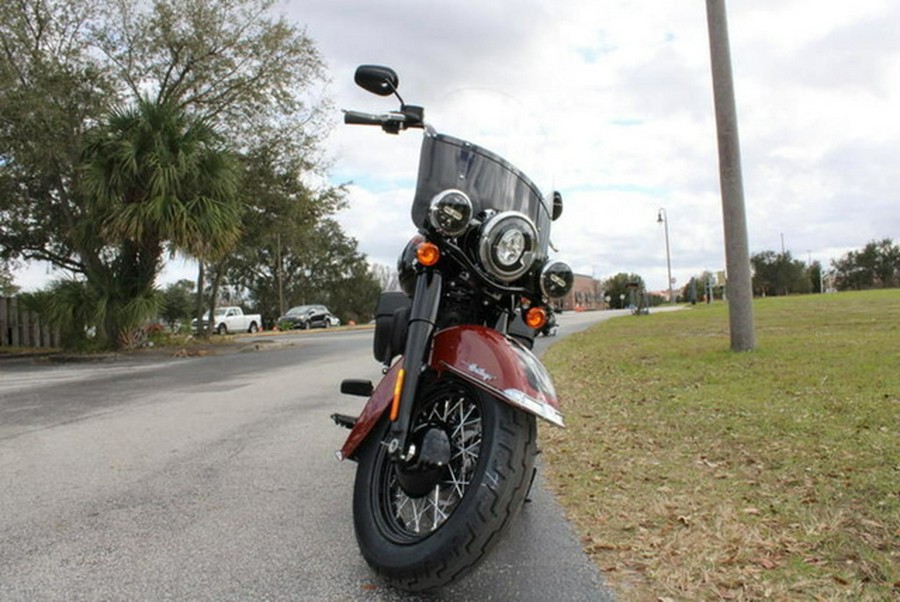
[82,99,240,345]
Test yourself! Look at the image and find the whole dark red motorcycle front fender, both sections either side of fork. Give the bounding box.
[338,326,565,458]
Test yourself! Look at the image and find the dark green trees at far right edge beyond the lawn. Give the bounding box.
[831,238,900,290]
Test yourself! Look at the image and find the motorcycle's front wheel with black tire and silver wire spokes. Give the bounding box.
[353,378,537,591]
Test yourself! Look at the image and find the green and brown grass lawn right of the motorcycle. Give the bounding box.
[541,290,900,601]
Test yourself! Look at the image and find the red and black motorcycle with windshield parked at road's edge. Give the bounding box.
[332,65,574,592]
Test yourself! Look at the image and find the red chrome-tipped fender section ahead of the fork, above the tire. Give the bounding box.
[430,326,565,426]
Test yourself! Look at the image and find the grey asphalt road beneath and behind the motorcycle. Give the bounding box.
[0,312,624,601]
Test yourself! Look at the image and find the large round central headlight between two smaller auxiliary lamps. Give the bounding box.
[478,211,537,282]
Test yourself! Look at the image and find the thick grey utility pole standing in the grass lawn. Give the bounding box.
[706,0,756,351]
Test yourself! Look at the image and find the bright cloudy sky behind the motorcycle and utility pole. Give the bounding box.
[17,0,900,290]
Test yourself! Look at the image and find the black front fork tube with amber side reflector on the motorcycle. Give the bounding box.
[387,270,443,461]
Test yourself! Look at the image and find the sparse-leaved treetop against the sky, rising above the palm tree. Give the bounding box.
[91,0,330,150]
